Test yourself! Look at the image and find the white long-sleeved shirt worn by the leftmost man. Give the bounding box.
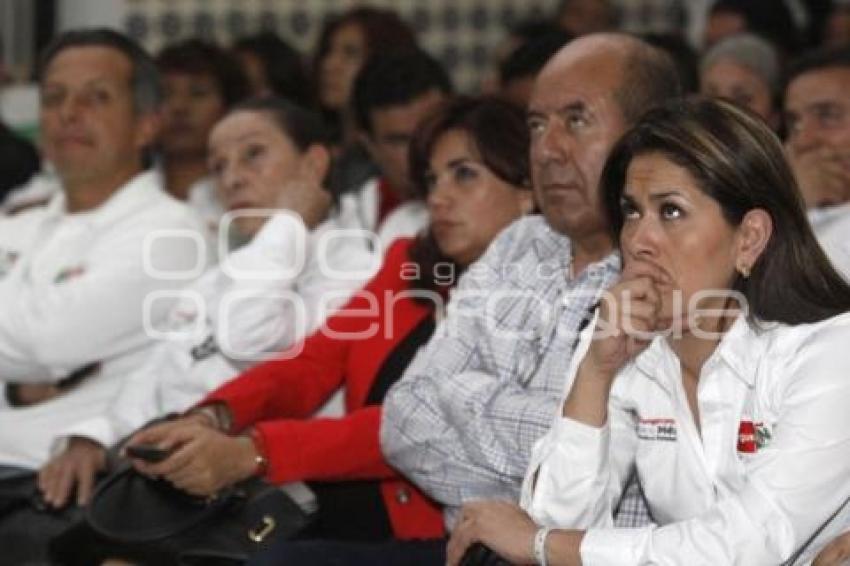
[0,172,205,468]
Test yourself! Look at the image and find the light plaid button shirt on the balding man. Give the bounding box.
[381,216,647,526]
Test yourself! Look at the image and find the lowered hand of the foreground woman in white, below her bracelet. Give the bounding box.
[447,501,538,566]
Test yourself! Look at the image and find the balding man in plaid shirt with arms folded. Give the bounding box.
[381,34,679,560]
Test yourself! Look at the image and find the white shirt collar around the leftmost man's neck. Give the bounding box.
[47,170,161,229]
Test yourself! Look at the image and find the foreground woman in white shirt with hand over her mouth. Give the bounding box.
[449,99,850,566]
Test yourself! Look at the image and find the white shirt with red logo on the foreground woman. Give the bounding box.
[522,314,850,566]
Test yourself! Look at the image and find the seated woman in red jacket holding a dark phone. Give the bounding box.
[129,98,533,563]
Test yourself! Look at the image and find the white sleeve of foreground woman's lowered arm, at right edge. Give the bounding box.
[581,324,850,566]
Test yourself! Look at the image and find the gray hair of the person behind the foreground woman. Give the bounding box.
[699,33,781,95]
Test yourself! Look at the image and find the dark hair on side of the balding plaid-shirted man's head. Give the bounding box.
[614,36,682,124]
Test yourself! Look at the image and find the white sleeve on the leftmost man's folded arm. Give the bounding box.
[0,222,197,382]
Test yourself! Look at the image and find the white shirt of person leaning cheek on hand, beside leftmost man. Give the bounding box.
[54,214,380,449]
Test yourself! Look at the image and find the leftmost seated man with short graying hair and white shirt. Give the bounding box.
[0,30,204,563]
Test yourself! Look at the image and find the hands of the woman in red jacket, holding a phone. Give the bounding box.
[133,421,256,497]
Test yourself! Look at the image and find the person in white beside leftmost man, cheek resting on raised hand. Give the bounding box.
[39,99,375,507]
